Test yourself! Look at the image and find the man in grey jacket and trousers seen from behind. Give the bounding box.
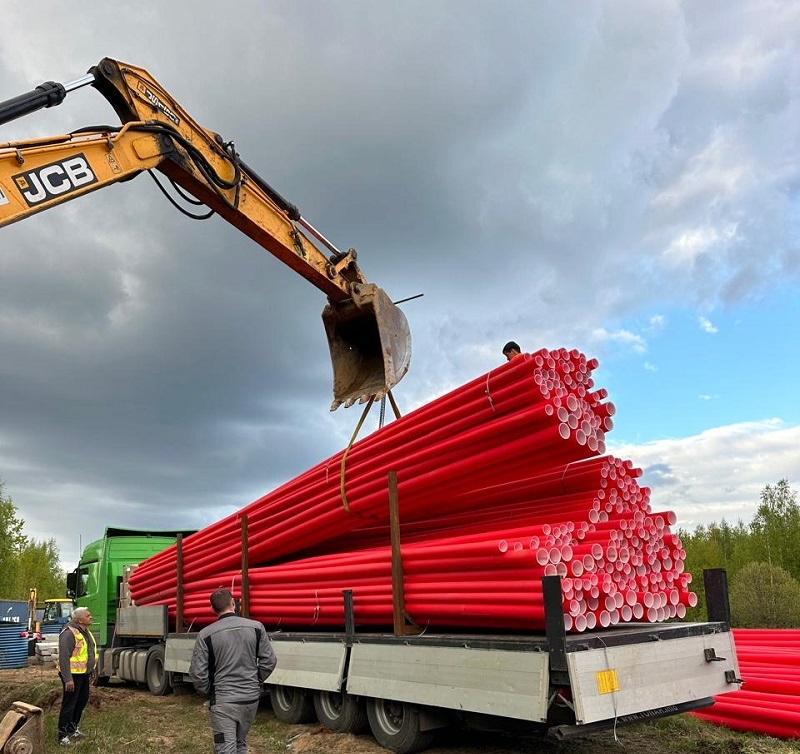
[189,589,278,754]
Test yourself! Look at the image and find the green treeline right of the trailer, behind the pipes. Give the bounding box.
[678,479,800,628]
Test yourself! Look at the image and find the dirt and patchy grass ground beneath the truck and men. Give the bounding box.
[0,665,788,754]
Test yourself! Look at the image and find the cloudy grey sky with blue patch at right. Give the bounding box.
[0,0,800,569]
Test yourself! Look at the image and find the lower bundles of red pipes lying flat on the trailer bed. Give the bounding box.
[141,484,694,631]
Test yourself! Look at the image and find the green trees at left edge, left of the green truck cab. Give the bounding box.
[0,482,66,600]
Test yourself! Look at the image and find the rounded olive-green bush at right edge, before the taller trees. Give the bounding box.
[730,563,800,628]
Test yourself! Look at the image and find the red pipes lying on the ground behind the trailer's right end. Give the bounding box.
[694,628,800,738]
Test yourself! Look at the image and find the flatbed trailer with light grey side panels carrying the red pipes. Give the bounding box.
[145,571,741,754]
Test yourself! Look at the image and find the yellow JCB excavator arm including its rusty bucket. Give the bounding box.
[0,58,411,409]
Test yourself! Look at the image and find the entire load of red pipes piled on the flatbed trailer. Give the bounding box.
[130,349,696,631]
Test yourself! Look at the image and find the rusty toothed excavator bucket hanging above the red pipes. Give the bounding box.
[322,283,411,411]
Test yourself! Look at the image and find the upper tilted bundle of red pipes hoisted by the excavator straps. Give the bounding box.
[131,349,614,594]
